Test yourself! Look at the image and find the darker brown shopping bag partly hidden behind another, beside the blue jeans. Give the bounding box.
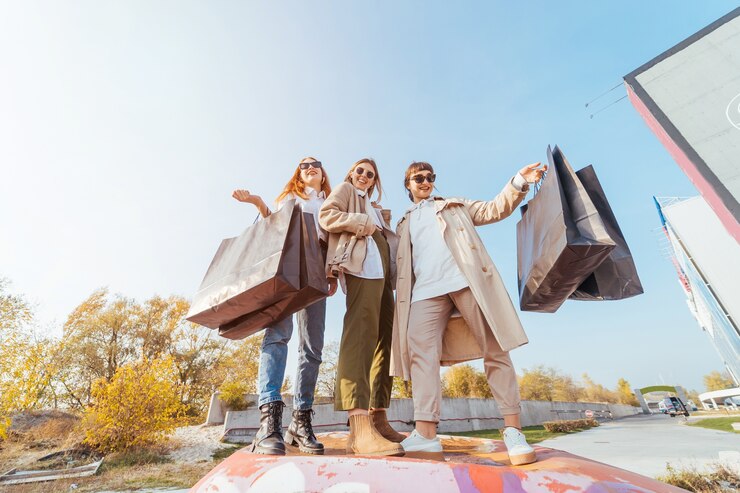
[218,209,328,339]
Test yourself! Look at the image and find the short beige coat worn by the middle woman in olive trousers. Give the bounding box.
[319,182,398,280]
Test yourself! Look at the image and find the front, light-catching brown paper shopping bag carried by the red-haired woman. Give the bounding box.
[186,201,302,329]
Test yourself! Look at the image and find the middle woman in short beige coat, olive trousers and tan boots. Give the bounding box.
[319,158,404,455]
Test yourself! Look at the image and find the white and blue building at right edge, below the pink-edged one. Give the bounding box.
[655,197,740,386]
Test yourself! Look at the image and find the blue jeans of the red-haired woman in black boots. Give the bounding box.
[257,298,326,410]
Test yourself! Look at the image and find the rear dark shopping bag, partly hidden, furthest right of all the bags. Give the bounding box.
[569,165,644,300]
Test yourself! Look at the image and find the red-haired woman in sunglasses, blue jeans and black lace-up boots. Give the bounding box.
[232,157,337,455]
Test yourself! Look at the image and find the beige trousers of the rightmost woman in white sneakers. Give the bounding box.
[408,288,521,423]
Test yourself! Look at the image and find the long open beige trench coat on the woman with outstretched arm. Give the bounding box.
[391,182,528,380]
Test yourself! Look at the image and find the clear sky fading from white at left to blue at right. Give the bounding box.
[0,0,735,391]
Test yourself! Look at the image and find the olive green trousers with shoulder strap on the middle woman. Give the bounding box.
[334,231,394,411]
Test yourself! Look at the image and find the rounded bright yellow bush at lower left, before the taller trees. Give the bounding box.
[83,358,185,452]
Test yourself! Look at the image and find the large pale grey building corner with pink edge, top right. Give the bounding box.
[624,8,740,240]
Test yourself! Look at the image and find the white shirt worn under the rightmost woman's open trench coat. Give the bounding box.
[408,173,527,303]
